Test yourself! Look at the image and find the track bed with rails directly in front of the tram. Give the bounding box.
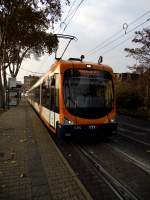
[51,131,150,200]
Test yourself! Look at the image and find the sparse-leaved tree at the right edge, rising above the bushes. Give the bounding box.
[125,28,150,110]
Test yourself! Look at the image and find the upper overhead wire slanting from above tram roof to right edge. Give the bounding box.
[86,10,150,56]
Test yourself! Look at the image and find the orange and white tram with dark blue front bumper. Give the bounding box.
[28,59,117,138]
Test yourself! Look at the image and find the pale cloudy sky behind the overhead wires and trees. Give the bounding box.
[17,0,150,82]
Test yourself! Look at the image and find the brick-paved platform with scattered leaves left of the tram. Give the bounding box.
[0,99,92,200]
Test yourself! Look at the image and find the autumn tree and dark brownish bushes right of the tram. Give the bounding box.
[116,29,150,118]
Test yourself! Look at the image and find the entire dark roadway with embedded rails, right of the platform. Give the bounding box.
[52,116,150,200]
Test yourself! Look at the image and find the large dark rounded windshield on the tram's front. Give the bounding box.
[63,69,114,119]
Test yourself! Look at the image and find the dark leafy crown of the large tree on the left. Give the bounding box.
[0,0,69,108]
